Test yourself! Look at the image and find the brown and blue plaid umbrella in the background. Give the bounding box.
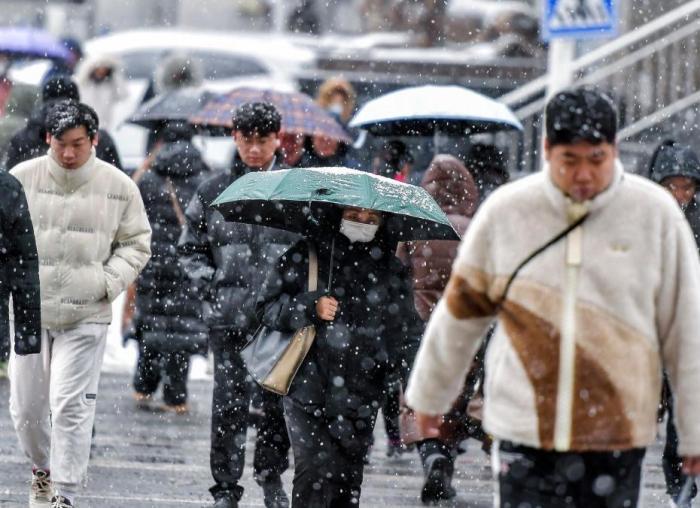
[189,88,352,143]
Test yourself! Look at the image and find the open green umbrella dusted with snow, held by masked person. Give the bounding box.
[212,168,459,241]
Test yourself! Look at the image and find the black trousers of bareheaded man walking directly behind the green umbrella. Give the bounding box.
[209,331,289,499]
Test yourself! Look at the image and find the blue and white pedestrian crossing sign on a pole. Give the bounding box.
[542,0,617,41]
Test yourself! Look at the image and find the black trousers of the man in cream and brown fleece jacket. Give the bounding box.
[498,441,646,508]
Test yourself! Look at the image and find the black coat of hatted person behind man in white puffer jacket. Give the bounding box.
[5,104,123,171]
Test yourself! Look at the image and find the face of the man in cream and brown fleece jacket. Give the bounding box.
[544,140,617,203]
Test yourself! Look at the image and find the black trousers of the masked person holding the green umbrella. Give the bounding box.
[284,397,378,508]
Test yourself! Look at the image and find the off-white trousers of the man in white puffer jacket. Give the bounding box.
[9,323,107,497]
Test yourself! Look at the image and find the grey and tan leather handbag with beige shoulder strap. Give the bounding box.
[241,243,318,395]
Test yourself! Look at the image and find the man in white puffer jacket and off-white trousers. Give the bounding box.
[9,101,151,508]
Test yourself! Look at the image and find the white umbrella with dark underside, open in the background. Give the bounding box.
[349,85,523,136]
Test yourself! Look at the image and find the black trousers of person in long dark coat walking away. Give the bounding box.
[134,341,190,406]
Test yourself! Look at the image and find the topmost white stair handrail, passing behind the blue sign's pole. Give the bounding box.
[499,0,700,107]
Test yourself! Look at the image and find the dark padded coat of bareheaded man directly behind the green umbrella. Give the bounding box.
[178,156,298,336]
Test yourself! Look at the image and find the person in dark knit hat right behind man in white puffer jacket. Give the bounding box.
[4,75,122,171]
